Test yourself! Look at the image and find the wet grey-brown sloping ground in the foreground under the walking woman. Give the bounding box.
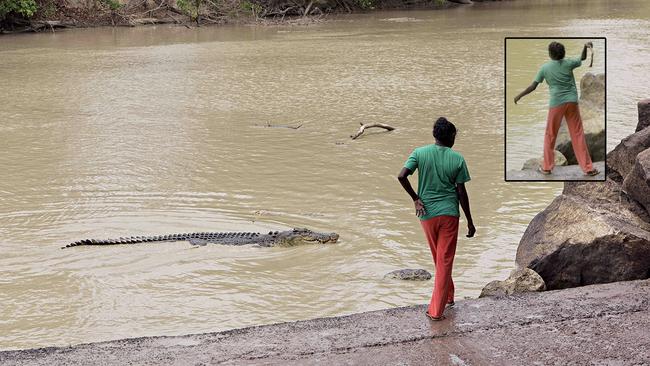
[0,280,650,366]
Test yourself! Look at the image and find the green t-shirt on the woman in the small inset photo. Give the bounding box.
[535,57,582,108]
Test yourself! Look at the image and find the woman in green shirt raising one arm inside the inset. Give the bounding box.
[515,42,599,176]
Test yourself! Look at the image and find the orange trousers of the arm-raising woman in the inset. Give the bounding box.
[542,102,594,173]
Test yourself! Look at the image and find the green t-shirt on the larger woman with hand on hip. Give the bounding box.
[404,144,470,220]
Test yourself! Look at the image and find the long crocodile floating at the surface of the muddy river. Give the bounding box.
[61,228,339,249]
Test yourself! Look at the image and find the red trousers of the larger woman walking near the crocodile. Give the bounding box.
[420,216,458,317]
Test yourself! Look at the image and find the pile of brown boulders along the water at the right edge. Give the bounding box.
[492,98,650,296]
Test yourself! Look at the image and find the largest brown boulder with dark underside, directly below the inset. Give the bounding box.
[516,180,650,289]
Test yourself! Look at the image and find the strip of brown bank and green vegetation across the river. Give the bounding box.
[0,0,449,33]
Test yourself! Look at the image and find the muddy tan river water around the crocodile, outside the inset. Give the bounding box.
[0,0,650,349]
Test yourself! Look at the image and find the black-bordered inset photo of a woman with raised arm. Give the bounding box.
[504,37,607,182]
